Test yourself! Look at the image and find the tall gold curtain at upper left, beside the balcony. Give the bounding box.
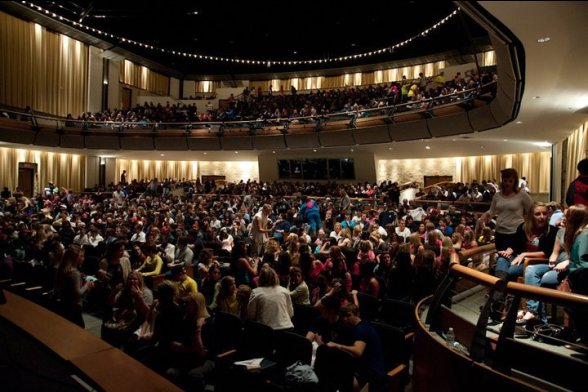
[0,12,88,117]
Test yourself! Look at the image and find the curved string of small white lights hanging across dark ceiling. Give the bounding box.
[22,1,460,67]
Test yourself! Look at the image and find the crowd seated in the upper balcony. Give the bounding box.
[67,72,496,127]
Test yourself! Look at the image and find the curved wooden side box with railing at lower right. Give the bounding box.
[413,245,588,391]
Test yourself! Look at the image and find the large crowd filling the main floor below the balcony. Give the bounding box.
[0,159,588,389]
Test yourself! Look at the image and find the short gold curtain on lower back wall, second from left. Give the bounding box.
[115,159,198,181]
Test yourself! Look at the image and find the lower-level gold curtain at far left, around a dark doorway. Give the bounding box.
[0,148,86,192]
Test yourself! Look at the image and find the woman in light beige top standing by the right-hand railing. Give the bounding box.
[481,169,533,264]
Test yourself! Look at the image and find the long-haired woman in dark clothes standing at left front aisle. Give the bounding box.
[54,245,94,328]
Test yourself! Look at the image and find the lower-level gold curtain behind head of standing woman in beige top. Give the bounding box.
[456,151,551,193]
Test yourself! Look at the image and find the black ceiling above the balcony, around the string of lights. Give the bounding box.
[31,0,487,78]
